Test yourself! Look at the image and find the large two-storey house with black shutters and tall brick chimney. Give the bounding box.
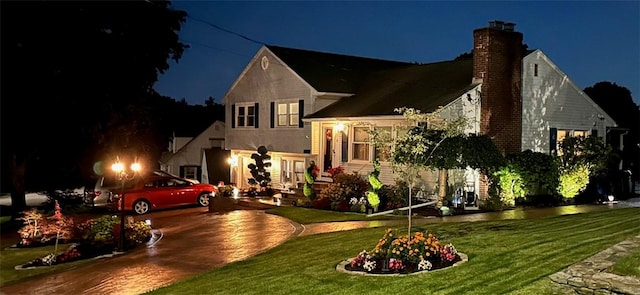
[224,21,616,198]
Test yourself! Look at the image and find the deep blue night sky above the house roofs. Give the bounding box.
[155,1,640,105]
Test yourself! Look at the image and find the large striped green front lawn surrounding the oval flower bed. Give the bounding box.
[149,208,640,295]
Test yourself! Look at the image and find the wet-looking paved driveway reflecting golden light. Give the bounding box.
[0,208,296,295]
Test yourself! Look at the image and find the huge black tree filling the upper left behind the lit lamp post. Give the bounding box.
[0,1,186,217]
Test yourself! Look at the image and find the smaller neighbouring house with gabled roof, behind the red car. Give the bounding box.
[160,121,229,184]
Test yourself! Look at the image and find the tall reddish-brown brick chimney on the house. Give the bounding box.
[473,21,522,153]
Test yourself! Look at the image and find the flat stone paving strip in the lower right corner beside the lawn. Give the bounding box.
[549,236,640,295]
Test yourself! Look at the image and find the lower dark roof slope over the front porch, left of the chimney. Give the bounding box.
[304,59,478,119]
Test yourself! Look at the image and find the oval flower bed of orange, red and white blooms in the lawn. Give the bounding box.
[338,229,467,274]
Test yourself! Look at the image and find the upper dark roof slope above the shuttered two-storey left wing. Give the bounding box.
[265,45,411,93]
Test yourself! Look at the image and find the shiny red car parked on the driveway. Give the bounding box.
[112,174,217,214]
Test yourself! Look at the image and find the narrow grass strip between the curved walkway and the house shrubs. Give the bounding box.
[266,206,407,224]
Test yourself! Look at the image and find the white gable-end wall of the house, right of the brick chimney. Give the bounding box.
[522,50,615,153]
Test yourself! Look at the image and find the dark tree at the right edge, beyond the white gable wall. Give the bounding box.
[584,81,640,183]
